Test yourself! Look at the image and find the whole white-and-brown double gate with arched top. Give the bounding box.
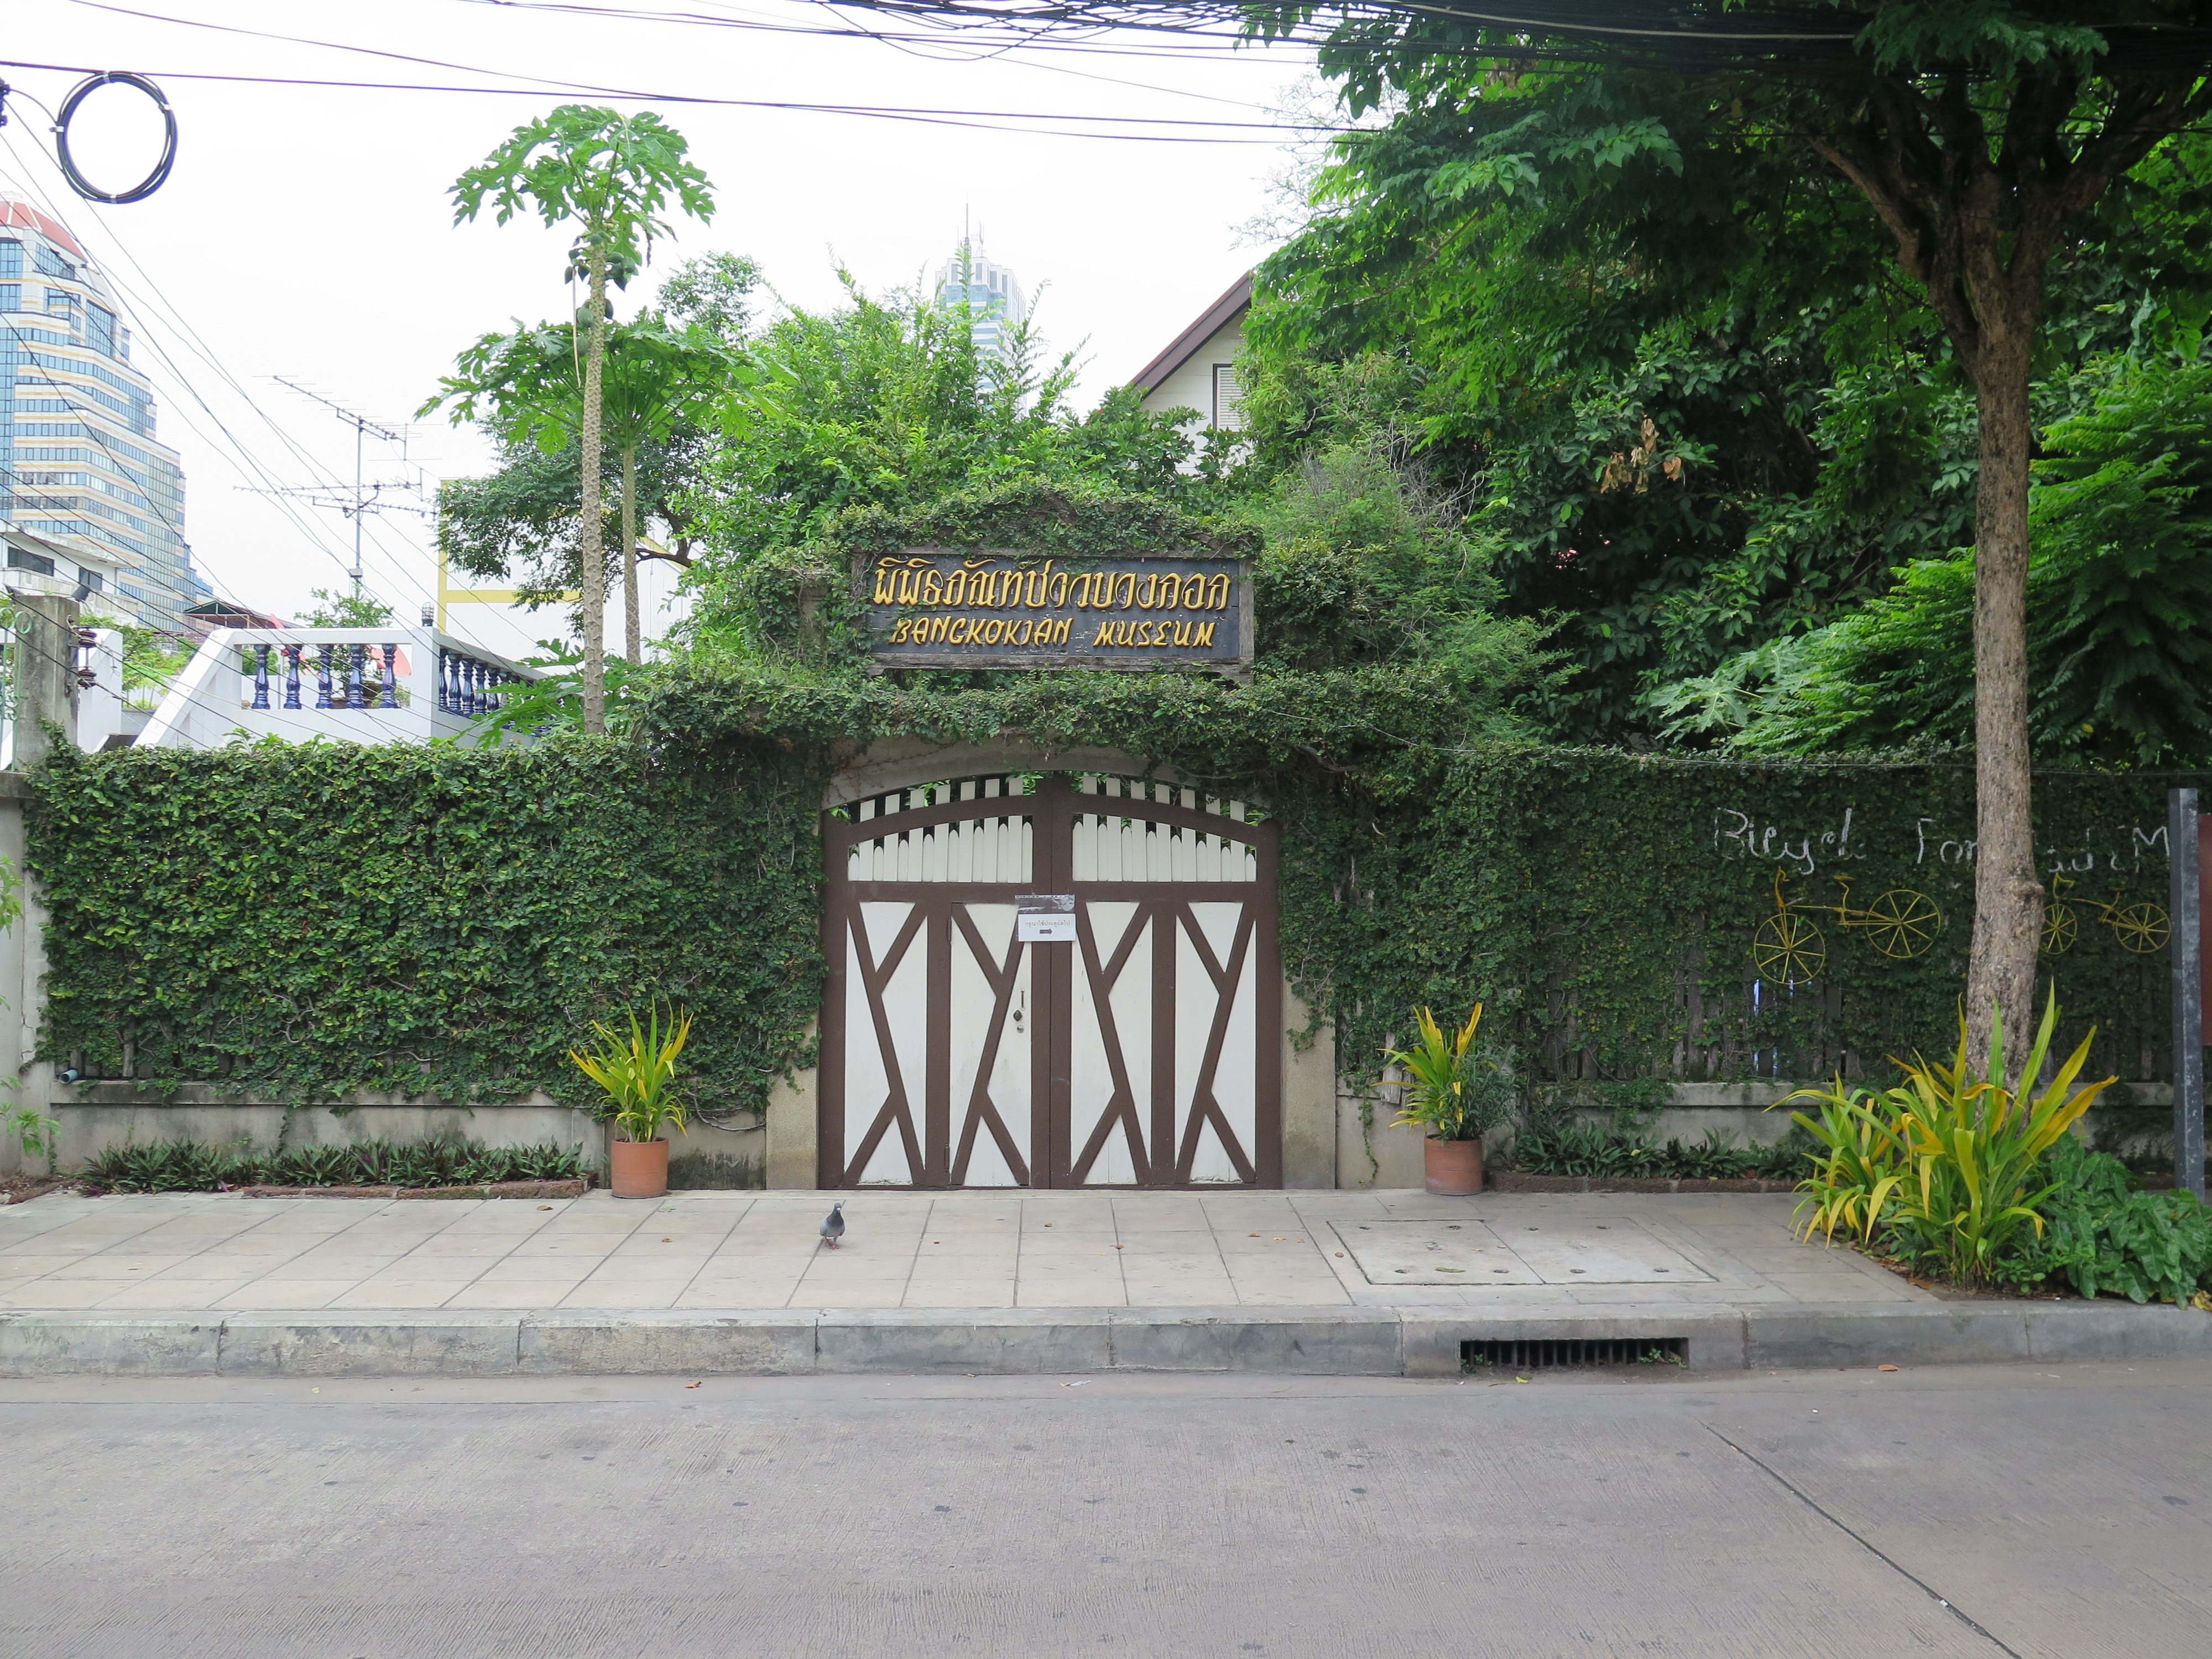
[818,776,1283,1188]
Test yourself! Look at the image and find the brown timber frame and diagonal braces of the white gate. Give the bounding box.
[814,774,1283,1192]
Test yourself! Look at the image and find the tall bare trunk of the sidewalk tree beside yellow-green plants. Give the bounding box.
[1966,325,2044,1073]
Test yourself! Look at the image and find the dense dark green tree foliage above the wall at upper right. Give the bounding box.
[1243,18,2212,739]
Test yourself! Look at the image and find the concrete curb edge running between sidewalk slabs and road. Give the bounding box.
[0,1303,2212,1378]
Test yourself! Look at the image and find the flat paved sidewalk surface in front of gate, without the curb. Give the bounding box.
[0,1190,1902,1312]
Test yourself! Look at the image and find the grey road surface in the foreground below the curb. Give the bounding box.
[0,1360,2212,1659]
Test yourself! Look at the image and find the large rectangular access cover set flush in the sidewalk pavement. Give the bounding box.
[1334,1217,1712,1285]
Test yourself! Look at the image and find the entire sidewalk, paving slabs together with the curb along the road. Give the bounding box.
[0,1192,2212,1376]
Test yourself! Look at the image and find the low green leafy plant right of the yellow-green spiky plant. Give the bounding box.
[1993,1135,2212,1303]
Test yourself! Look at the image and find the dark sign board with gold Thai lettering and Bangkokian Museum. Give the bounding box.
[865,551,1243,666]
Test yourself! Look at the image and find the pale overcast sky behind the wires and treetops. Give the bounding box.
[0,0,1310,637]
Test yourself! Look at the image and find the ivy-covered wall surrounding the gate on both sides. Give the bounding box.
[31,699,2170,1106]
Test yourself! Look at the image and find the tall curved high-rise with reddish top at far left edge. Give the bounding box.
[0,197,210,633]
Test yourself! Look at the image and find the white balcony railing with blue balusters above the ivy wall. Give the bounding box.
[137,628,544,750]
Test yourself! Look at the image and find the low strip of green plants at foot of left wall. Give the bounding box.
[84,1139,591,1192]
